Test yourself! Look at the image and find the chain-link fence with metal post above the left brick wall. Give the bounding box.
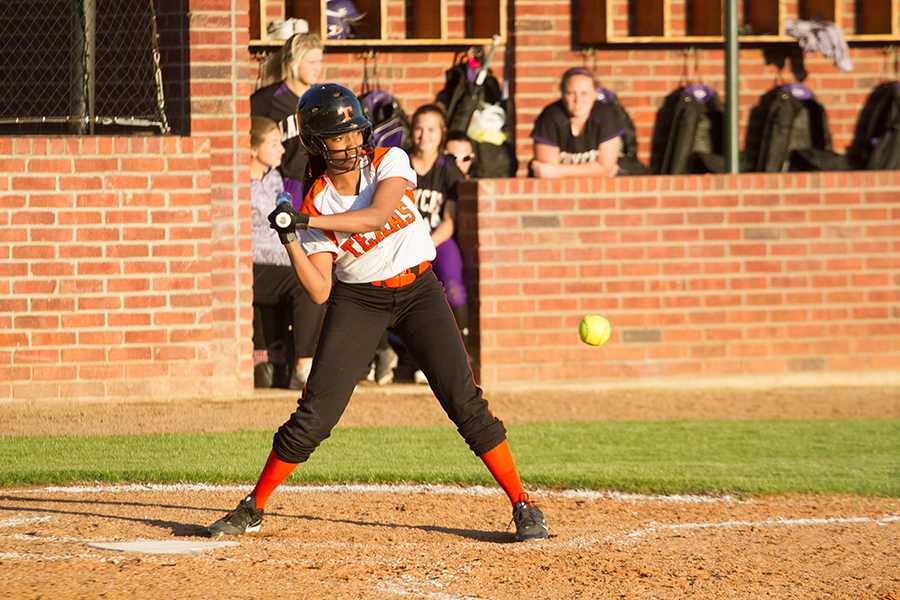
[0,0,170,134]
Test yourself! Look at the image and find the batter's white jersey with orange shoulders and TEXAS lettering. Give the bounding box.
[298,148,435,283]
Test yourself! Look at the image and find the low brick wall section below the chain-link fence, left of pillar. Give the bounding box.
[0,137,214,400]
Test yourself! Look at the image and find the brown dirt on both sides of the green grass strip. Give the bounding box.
[0,386,900,600]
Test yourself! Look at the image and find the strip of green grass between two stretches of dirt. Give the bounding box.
[0,419,900,497]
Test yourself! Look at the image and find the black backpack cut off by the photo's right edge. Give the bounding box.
[847,81,900,170]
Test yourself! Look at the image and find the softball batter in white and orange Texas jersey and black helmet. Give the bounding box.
[208,84,548,540]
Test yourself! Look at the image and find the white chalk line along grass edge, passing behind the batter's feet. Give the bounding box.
[7,483,743,504]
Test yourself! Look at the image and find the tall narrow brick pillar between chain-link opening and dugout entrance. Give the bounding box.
[189,0,253,394]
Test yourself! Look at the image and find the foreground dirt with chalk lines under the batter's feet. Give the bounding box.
[0,488,900,600]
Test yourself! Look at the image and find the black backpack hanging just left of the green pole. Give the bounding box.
[650,84,724,175]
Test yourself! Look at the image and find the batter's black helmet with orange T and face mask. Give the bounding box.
[297,83,372,174]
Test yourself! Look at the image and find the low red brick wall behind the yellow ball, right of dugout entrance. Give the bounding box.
[461,172,900,384]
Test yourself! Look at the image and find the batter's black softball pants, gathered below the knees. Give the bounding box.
[272,269,506,463]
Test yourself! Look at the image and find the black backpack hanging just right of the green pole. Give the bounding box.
[741,83,846,173]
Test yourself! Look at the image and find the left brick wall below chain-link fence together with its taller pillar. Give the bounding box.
[0,0,252,400]
